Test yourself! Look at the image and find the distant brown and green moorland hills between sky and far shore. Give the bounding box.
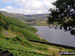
[0,11,48,25]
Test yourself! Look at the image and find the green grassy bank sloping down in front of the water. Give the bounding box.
[0,15,74,56]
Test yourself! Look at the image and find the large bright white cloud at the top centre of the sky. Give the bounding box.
[13,0,56,9]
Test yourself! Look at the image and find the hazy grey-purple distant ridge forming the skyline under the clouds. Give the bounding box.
[0,11,48,20]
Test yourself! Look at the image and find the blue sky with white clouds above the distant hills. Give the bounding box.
[0,0,56,14]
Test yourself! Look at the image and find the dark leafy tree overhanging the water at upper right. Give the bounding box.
[48,0,75,33]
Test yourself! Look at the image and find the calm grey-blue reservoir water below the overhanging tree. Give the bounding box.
[34,26,75,47]
